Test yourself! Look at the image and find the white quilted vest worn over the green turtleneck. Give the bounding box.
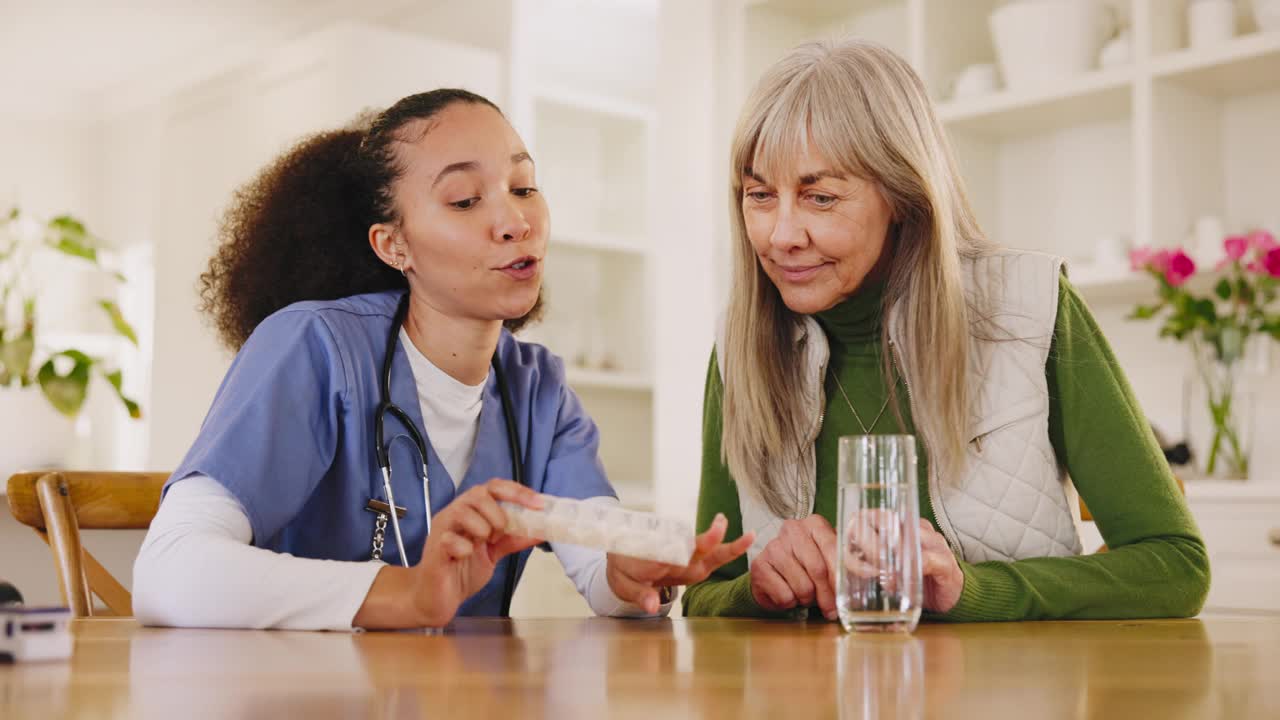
[716,250,1080,562]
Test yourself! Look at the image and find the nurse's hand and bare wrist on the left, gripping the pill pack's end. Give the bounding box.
[352,479,543,628]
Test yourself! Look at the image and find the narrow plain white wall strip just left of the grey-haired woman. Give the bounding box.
[652,3,727,520]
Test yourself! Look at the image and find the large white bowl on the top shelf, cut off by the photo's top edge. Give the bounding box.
[988,0,1108,90]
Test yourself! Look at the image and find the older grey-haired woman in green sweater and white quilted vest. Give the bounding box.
[684,42,1208,621]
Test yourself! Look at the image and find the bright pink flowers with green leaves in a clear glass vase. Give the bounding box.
[1130,231,1280,479]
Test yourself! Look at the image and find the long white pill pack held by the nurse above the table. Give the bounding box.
[502,495,694,565]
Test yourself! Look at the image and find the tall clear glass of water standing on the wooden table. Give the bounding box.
[833,436,924,633]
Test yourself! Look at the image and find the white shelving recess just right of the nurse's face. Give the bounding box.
[506,0,658,509]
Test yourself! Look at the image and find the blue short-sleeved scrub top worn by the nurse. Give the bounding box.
[165,291,616,615]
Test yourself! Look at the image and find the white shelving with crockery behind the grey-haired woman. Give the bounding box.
[714,0,1280,476]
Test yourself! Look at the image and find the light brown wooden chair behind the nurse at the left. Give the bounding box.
[9,471,169,618]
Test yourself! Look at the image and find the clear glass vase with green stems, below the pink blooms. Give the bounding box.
[1183,338,1267,480]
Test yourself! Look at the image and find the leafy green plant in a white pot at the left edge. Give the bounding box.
[0,208,142,480]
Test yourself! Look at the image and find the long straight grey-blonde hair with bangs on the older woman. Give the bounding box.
[721,41,987,516]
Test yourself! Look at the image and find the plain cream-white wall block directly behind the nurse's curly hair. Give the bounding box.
[150,26,502,469]
